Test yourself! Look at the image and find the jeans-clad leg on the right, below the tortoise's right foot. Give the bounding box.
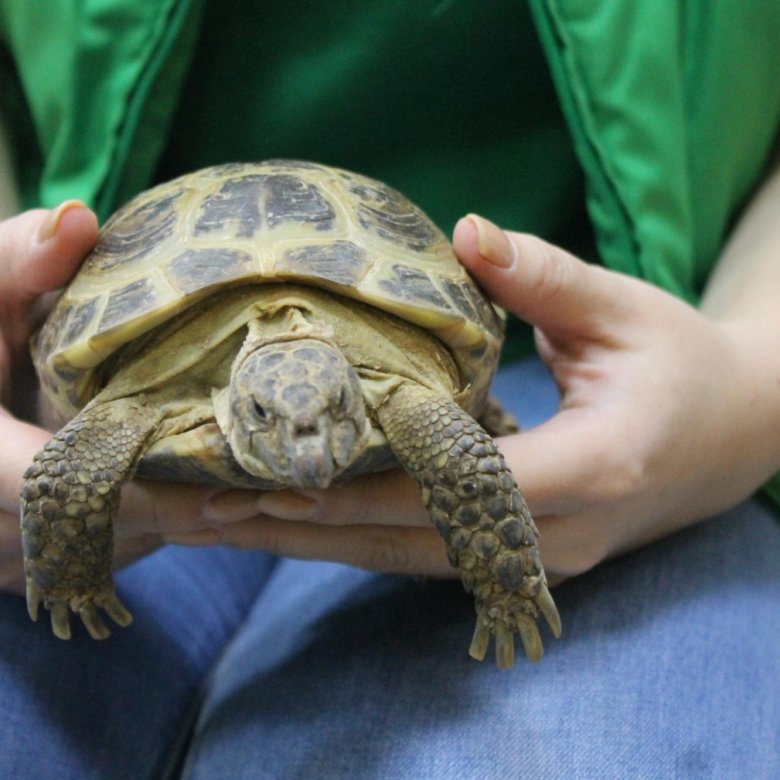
[185,501,780,778]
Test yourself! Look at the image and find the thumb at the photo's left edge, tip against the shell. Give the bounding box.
[0,200,98,300]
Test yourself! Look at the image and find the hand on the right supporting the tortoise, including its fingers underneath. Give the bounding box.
[167,218,780,582]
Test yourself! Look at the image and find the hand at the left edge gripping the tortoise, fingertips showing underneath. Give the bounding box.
[0,201,225,593]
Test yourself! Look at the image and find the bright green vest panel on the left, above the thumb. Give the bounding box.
[0,0,204,217]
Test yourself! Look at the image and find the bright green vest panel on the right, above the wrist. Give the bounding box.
[532,0,780,300]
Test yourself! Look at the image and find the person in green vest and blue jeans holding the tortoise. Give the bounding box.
[0,0,780,778]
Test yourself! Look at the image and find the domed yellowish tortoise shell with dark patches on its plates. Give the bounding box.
[33,160,503,418]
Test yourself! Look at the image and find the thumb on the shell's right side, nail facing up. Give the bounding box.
[453,214,633,340]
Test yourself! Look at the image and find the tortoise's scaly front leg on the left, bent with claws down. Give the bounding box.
[21,399,160,639]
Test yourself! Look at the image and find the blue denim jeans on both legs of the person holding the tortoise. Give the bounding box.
[0,362,780,780]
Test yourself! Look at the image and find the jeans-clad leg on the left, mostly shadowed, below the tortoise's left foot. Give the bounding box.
[0,548,274,780]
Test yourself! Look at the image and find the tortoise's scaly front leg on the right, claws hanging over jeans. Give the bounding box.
[378,383,561,668]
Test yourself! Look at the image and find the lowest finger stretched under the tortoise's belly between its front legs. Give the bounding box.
[165,516,458,577]
